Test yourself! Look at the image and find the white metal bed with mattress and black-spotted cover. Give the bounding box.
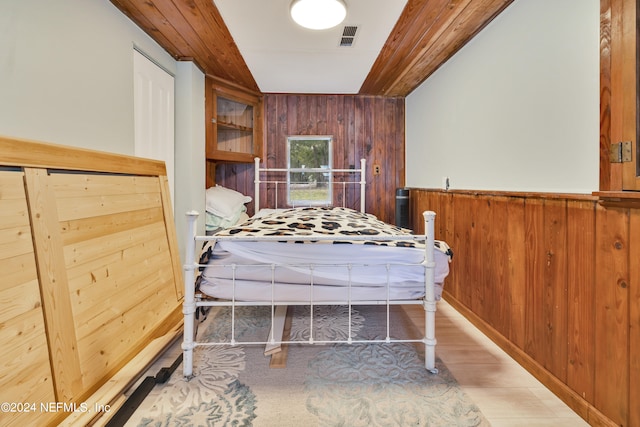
[182,160,452,378]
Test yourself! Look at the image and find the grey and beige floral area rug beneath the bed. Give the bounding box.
[127,306,489,427]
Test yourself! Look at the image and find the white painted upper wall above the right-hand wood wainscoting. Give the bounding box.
[406,0,600,193]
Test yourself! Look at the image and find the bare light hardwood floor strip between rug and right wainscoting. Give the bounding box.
[404,300,588,427]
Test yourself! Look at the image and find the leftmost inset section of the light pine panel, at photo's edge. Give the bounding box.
[0,172,56,425]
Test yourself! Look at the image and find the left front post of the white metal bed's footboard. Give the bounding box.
[182,211,198,379]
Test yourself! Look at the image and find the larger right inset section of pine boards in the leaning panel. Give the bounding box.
[50,173,176,387]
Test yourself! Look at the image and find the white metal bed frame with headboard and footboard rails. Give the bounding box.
[182,159,438,379]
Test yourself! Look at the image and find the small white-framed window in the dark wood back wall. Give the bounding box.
[287,136,333,206]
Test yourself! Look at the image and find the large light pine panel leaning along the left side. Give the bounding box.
[0,137,183,425]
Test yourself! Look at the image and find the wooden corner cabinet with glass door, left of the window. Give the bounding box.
[205,77,263,187]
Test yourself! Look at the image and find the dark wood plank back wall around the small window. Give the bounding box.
[216,95,405,222]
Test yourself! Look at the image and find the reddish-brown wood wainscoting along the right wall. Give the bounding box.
[410,189,640,426]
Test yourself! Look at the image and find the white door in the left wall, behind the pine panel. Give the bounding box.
[133,49,175,210]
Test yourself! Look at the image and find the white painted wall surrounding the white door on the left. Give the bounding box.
[0,0,205,260]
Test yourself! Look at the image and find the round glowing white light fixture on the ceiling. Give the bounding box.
[290,0,347,30]
